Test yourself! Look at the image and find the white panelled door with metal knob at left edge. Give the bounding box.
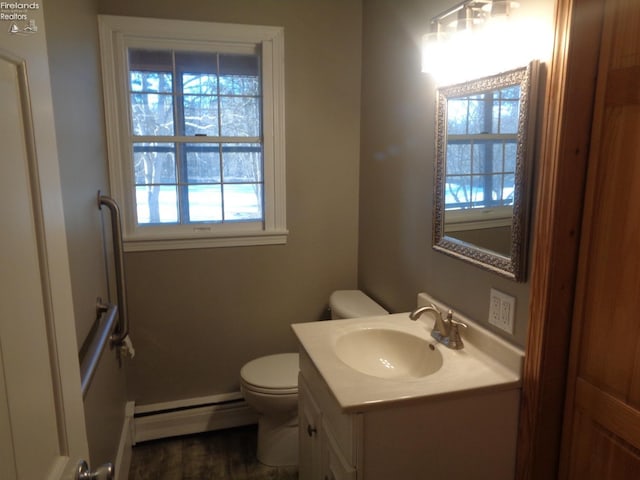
[0,3,88,480]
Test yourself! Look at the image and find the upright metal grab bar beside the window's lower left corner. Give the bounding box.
[98,190,129,345]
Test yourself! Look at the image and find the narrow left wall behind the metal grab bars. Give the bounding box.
[43,0,126,466]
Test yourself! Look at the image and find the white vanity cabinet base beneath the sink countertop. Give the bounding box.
[299,348,520,480]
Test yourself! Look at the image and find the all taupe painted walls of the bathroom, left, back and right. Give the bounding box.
[45,0,552,464]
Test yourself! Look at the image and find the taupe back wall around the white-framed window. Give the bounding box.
[99,0,361,404]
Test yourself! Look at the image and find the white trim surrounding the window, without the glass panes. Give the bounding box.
[98,15,288,251]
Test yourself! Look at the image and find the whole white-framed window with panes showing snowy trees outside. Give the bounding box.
[99,15,287,251]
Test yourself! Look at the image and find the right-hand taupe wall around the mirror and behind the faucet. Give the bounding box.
[358,0,553,345]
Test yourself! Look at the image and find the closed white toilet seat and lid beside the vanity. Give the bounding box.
[240,353,299,395]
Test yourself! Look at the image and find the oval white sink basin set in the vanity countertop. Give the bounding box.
[335,328,442,379]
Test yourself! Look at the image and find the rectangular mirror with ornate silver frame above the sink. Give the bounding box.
[433,61,539,281]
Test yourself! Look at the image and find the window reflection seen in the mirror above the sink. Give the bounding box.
[444,85,520,210]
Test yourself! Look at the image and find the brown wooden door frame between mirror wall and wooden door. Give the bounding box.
[516,0,605,480]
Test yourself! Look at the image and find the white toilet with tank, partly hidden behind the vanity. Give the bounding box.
[240,290,389,467]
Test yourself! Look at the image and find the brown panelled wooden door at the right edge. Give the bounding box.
[560,0,640,474]
